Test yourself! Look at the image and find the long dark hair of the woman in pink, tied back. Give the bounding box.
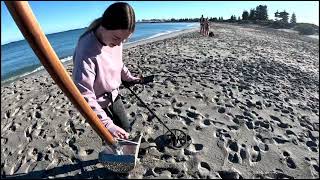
[80,2,136,37]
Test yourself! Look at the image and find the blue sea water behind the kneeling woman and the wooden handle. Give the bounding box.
[1,23,199,83]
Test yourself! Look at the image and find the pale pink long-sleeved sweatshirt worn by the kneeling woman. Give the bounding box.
[72,32,139,127]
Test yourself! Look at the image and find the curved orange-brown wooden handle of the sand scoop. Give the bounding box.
[5,1,116,145]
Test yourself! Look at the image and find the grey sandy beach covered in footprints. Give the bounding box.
[1,24,319,179]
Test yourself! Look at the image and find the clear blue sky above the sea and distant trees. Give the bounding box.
[1,1,319,45]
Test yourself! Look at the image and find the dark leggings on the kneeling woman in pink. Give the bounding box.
[103,95,131,132]
